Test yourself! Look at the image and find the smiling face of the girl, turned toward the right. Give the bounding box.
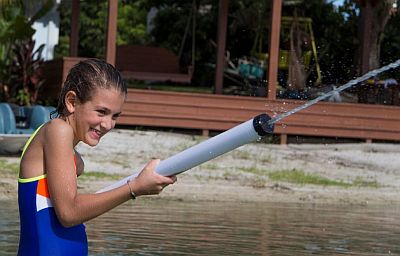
[73,88,125,146]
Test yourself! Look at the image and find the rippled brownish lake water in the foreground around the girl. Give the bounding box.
[0,198,400,255]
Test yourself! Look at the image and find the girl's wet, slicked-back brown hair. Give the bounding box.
[52,59,127,116]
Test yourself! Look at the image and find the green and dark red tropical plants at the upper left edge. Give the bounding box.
[0,0,54,104]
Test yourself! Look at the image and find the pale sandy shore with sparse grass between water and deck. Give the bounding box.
[0,129,400,204]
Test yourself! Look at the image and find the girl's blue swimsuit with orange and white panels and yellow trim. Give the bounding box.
[18,127,88,256]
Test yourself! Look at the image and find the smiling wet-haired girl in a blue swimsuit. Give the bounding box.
[18,59,176,255]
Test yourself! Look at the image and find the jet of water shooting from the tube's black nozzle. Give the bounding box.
[268,59,400,125]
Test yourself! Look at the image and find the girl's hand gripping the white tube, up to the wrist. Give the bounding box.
[129,159,177,196]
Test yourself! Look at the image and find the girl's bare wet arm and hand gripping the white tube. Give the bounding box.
[43,122,176,227]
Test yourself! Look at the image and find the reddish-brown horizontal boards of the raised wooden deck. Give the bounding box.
[118,89,400,144]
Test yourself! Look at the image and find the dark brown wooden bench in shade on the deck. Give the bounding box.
[115,45,193,83]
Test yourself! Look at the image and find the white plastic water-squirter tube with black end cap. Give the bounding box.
[97,114,273,193]
